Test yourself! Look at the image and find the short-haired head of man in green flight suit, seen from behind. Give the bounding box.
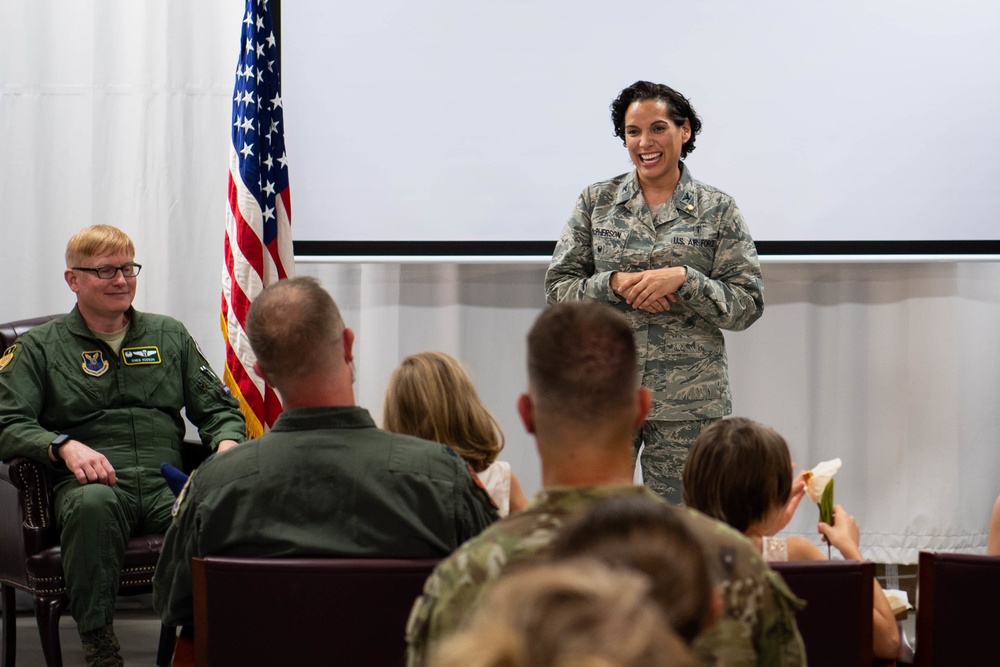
[246,277,354,408]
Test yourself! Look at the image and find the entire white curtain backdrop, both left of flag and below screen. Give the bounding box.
[0,0,1000,562]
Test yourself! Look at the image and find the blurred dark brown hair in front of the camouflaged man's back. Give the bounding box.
[551,496,722,643]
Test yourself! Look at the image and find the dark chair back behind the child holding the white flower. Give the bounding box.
[770,560,875,667]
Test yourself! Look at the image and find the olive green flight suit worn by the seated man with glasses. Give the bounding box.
[0,308,246,632]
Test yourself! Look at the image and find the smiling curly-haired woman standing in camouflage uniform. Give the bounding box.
[545,82,764,503]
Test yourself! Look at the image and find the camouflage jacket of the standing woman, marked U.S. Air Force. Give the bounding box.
[545,164,764,421]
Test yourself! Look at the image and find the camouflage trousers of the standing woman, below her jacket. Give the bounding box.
[634,419,718,505]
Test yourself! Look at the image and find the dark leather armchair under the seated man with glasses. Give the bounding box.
[0,315,207,667]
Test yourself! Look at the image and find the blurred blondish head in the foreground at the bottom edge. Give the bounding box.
[430,560,695,667]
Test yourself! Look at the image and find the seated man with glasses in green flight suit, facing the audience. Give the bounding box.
[0,225,246,667]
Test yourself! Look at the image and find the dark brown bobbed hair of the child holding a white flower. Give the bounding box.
[684,417,792,535]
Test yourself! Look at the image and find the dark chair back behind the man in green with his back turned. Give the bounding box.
[192,557,438,667]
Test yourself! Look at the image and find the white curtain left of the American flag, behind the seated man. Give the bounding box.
[0,0,243,354]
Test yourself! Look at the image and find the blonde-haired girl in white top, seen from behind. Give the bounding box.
[382,352,528,517]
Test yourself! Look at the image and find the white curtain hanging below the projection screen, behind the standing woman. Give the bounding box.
[297,260,1000,563]
